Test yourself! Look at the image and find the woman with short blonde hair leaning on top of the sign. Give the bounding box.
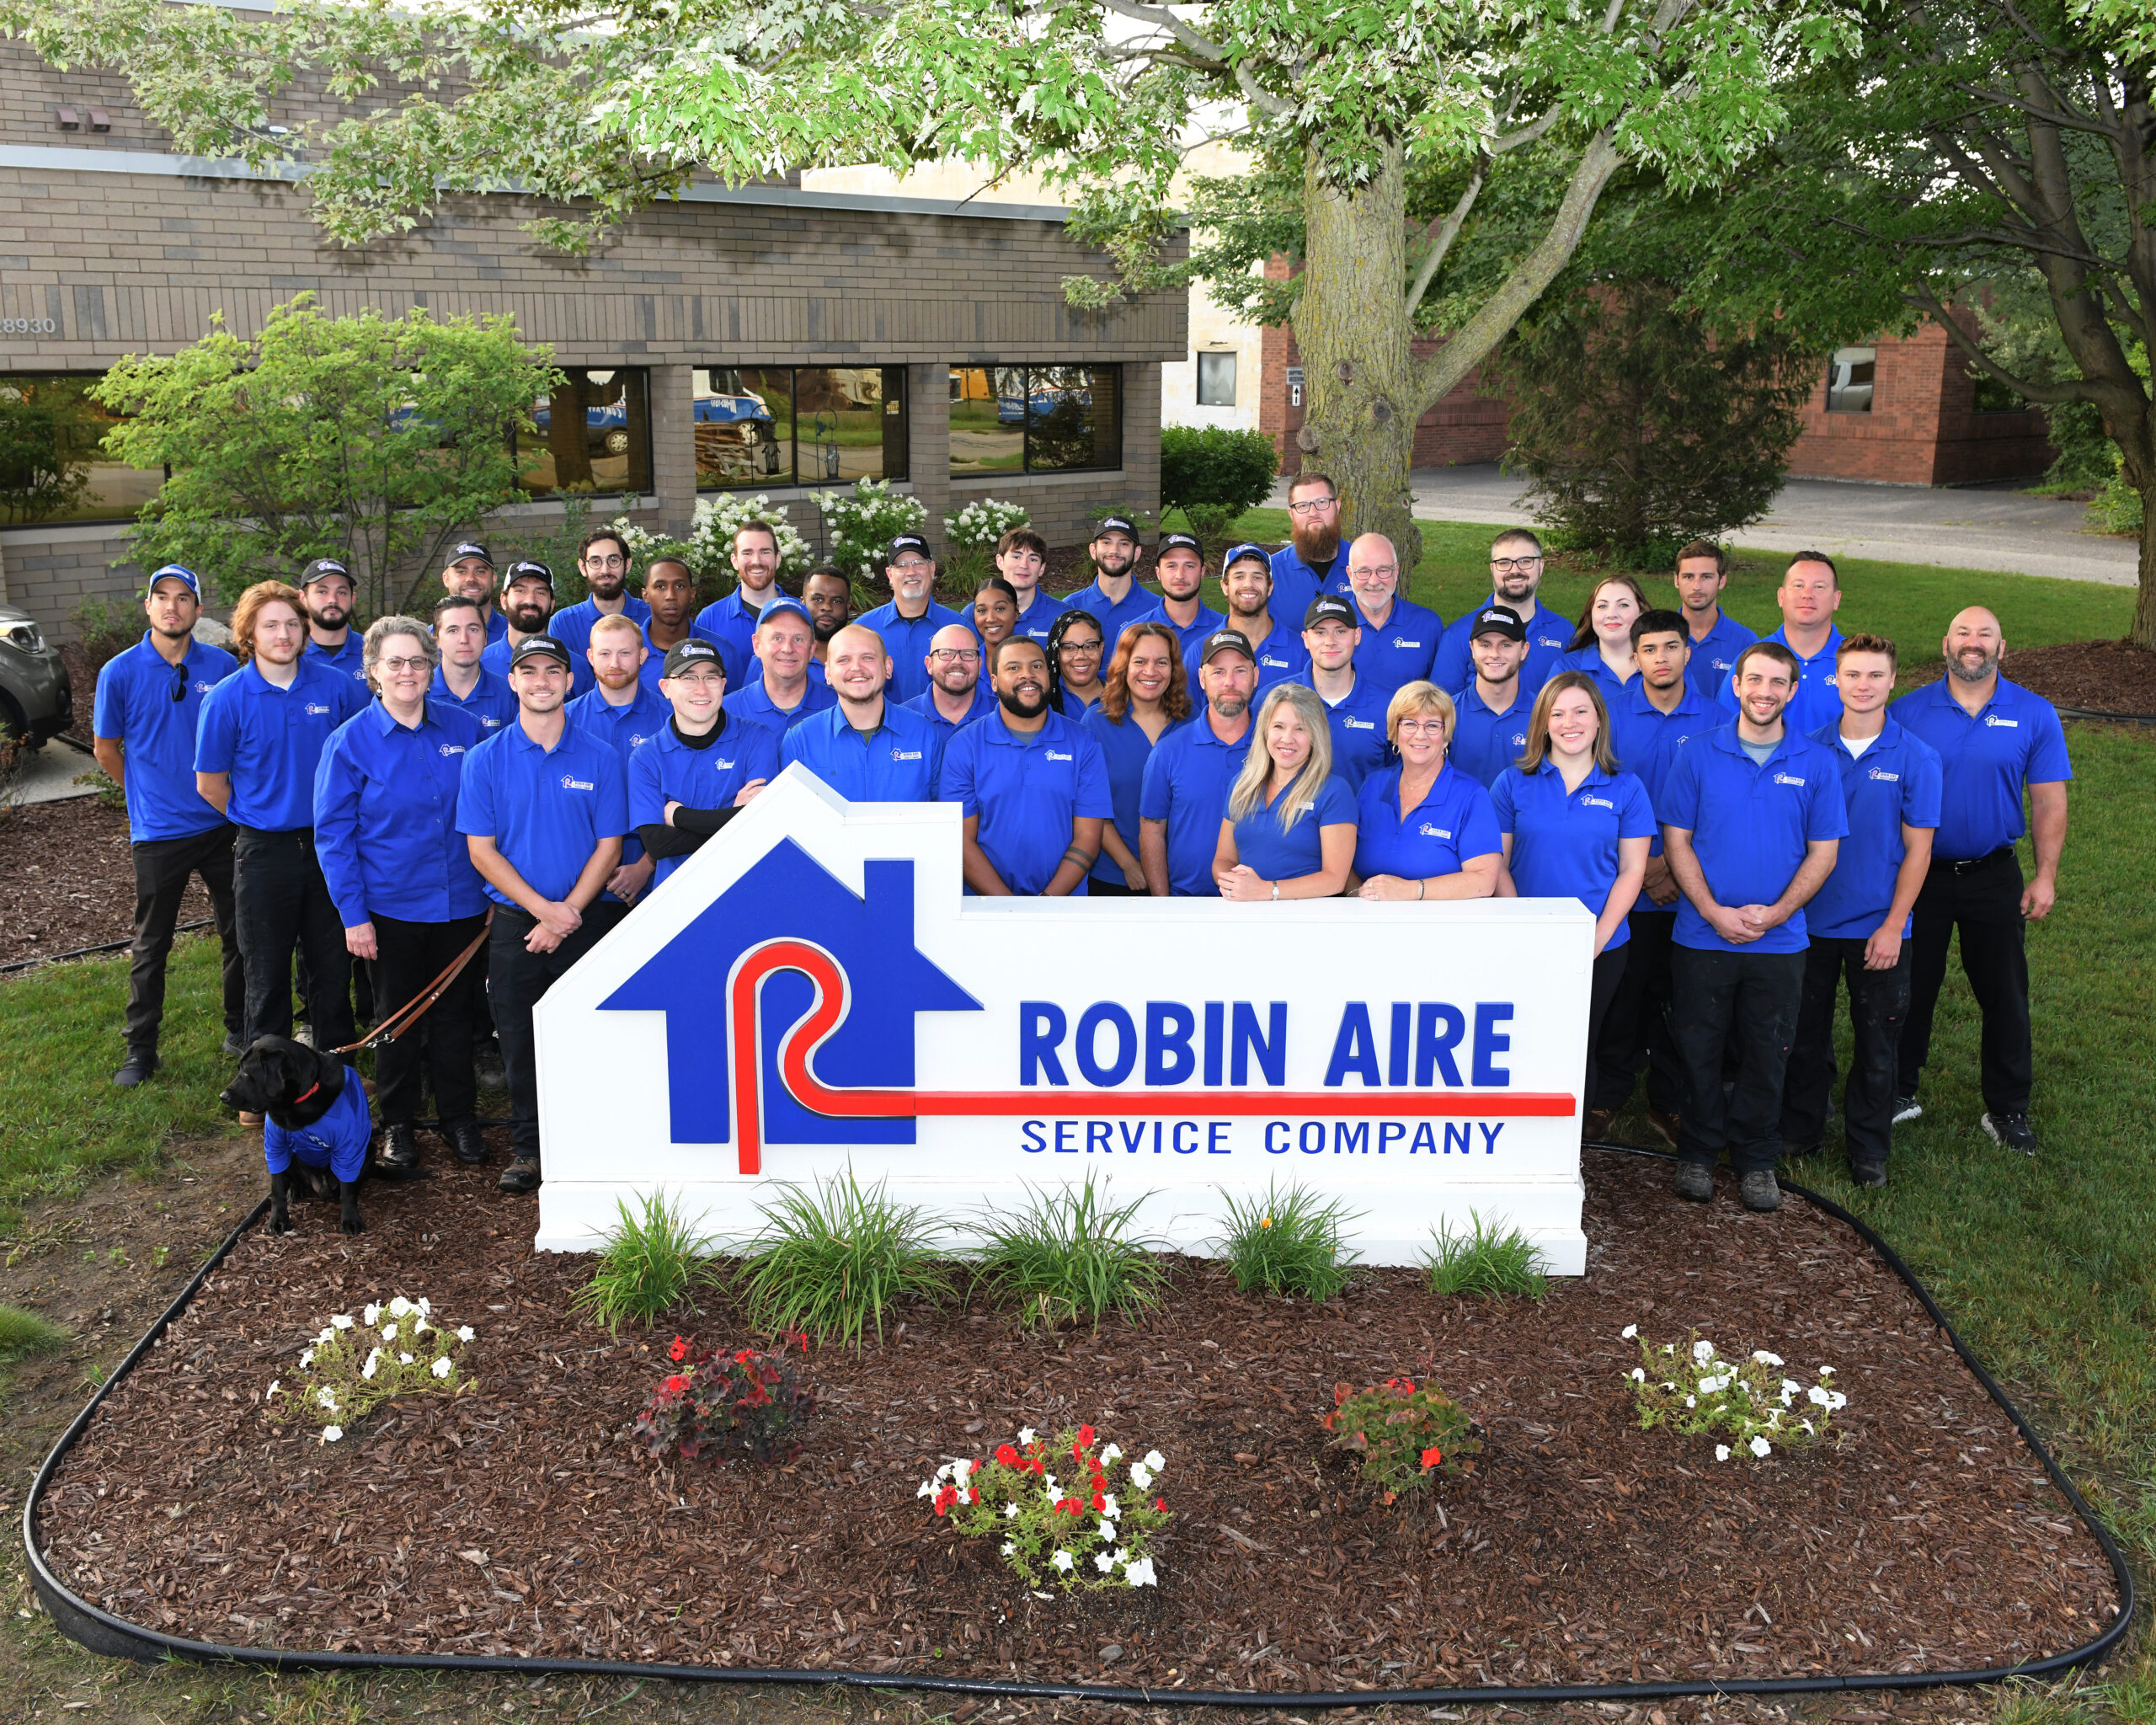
[1348,684,1502,901]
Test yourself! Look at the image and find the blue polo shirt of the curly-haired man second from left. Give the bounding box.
[195,654,366,832]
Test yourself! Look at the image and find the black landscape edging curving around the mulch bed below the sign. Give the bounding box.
[22,1143,2134,1708]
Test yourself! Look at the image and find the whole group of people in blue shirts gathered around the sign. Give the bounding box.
[95,474,2072,1210]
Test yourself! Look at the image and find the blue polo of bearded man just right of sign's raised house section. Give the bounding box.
[936,712,1115,897]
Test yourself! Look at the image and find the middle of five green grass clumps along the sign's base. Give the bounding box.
[981,1175,1166,1331]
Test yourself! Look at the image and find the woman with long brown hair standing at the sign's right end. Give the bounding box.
[1490,670,1654,1115]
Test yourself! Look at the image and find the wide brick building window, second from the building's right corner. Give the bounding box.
[696,365,908,492]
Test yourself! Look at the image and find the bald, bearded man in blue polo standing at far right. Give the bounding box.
[1891,606,2074,1156]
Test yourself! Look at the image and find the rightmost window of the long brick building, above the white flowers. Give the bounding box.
[951,365,1123,478]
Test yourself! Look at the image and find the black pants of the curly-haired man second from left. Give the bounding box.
[232,825,355,1050]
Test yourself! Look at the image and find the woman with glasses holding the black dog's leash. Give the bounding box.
[315,617,488,1173]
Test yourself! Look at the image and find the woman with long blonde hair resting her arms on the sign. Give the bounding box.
[1214,684,1354,904]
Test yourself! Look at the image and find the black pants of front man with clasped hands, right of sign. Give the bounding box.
[1668,947,1805,1173]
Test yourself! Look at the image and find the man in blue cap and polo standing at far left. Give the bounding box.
[91,563,248,1089]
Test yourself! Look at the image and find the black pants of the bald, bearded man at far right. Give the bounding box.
[1899,850,2036,1115]
